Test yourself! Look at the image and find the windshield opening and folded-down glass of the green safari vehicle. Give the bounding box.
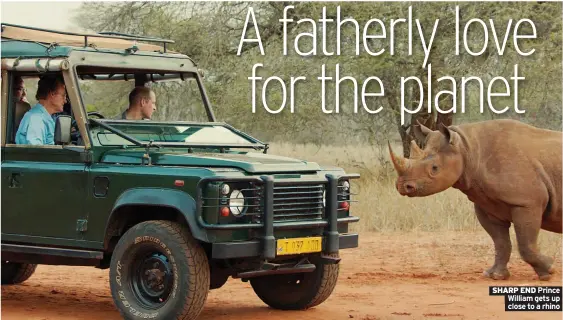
[77,67,262,148]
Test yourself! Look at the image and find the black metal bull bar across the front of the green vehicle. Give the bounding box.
[196,174,360,259]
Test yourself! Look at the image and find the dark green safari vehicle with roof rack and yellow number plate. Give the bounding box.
[1,24,359,320]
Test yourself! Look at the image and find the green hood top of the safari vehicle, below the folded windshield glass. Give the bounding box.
[100,150,321,173]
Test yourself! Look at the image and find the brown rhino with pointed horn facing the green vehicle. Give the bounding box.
[388,119,563,281]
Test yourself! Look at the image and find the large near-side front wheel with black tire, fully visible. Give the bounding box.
[109,221,210,320]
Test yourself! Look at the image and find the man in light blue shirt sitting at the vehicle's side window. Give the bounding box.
[16,76,67,145]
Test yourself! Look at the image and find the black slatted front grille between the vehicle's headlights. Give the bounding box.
[274,184,324,222]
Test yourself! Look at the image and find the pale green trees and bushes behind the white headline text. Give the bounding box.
[72,2,562,144]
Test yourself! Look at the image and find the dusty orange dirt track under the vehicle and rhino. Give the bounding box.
[2,233,562,320]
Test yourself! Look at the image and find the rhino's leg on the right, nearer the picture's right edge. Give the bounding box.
[512,207,553,281]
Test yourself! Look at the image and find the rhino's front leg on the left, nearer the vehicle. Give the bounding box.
[475,205,512,280]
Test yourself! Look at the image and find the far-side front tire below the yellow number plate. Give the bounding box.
[250,254,340,310]
